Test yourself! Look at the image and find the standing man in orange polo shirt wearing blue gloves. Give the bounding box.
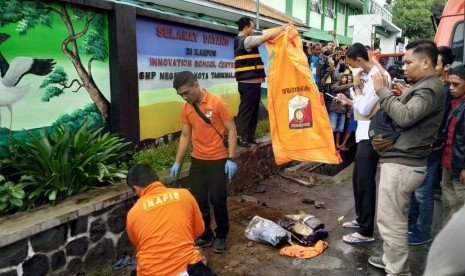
[170,71,237,253]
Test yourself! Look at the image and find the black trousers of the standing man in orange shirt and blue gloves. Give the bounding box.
[189,157,229,239]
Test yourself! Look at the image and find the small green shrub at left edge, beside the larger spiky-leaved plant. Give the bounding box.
[0,174,25,214]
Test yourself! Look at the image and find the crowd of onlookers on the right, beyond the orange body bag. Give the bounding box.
[304,36,465,275]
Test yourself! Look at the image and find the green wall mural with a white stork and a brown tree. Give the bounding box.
[0,0,110,155]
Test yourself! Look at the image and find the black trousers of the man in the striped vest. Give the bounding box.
[236,82,261,140]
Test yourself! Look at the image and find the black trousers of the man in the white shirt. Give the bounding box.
[352,140,379,237]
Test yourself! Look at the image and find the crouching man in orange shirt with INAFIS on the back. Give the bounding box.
[126,164,213,276]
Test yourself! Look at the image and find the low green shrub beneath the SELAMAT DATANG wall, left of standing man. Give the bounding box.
[131,140,192,171]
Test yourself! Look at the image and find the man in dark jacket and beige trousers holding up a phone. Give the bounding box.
[368,40,445,275]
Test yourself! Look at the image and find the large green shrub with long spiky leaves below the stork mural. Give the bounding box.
[2,121,129,210]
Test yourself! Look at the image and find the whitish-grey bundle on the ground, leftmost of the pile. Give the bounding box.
[245,216,291,246]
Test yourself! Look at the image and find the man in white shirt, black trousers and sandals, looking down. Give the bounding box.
[338,43,390,244]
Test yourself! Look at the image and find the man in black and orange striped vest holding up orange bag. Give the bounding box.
[234,16,292,148]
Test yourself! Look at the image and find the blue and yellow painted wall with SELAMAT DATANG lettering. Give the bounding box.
[137,17,239,140]
